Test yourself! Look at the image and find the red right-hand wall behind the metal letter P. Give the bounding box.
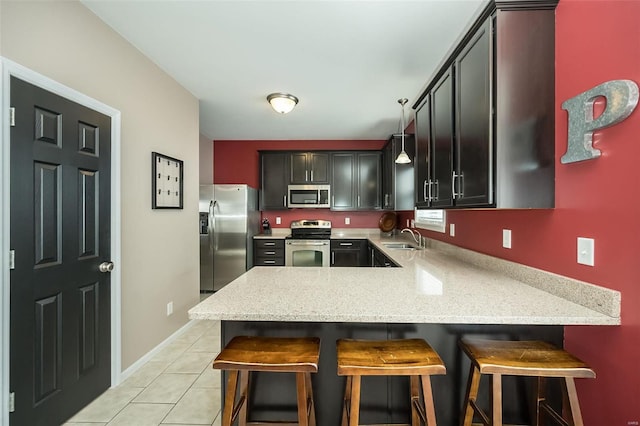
[402,0,640,426]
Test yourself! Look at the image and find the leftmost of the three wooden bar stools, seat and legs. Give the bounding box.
[213,336,320,426]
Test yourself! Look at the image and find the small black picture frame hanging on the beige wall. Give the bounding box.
[151,152,184,209]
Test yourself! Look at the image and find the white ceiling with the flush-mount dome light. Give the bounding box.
[82,0,486,140]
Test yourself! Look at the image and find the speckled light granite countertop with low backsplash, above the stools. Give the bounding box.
[189,230,620,325]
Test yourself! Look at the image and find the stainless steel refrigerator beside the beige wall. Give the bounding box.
[200,185,260,292]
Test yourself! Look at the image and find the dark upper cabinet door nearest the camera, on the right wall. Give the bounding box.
[454,19,493,206]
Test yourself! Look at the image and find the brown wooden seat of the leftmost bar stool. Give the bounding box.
[213,336,320,373]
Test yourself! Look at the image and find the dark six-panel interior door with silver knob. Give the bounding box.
[10,78,111,425]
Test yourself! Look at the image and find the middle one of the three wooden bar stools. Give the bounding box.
[337,339,446,426]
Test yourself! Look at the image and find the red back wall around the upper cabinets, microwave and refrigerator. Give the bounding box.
[213,140,396,228]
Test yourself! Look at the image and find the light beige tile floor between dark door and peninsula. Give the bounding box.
[65,321,221,426]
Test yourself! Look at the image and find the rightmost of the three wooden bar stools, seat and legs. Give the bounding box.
[460,338,596,426]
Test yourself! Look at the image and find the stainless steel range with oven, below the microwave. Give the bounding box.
[284,219,331,266]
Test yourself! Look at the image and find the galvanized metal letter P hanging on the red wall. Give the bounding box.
[560,80,638,164]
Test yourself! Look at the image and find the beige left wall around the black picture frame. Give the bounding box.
[0,0,199,370]
